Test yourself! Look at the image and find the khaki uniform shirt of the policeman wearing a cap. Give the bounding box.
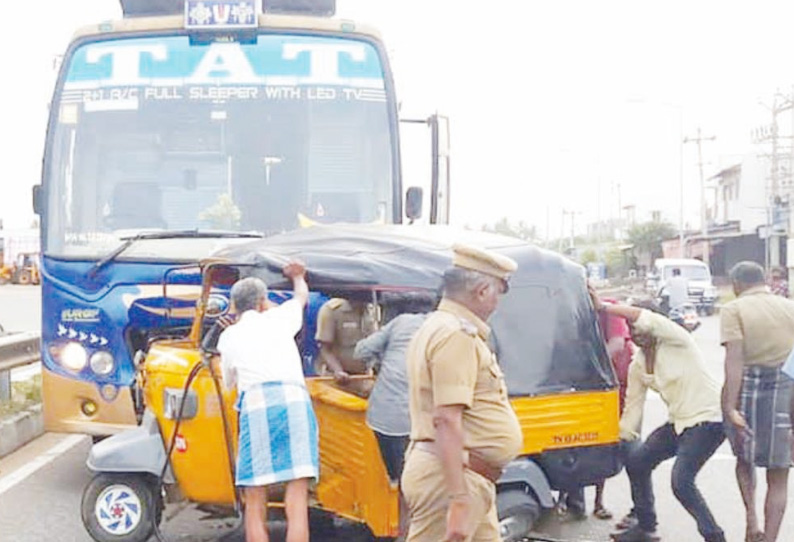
[406,299,523,467]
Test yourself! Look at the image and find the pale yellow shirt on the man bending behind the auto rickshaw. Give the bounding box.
[620,310,722,440]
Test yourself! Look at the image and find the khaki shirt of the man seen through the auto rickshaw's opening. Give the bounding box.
[315,298,377,374]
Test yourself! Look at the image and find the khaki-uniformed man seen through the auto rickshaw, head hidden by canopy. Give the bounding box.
[315,297,378,395]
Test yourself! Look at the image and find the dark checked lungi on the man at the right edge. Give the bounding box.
[727,366,794,469]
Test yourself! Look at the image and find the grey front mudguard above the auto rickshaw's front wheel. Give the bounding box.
[86,409,176,484]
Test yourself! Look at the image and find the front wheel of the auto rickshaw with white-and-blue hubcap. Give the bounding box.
[80,473,163,542]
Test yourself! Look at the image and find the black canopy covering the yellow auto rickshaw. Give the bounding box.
[213,225,617,396]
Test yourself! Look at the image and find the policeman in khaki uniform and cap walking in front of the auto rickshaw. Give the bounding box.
[402,245,522,542]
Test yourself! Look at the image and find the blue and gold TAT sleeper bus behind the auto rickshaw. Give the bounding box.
[33,0,449,436]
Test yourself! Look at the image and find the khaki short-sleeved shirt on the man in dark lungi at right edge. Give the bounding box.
[720,286,794,367]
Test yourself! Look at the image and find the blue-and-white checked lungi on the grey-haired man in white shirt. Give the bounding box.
[235,382,319,486]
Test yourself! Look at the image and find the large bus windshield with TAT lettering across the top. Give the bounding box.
[44,34,399,257]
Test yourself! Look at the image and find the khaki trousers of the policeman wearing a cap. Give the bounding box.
[402,448,502,542]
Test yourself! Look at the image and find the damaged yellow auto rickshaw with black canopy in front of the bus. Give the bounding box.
[82,225,621,542]
